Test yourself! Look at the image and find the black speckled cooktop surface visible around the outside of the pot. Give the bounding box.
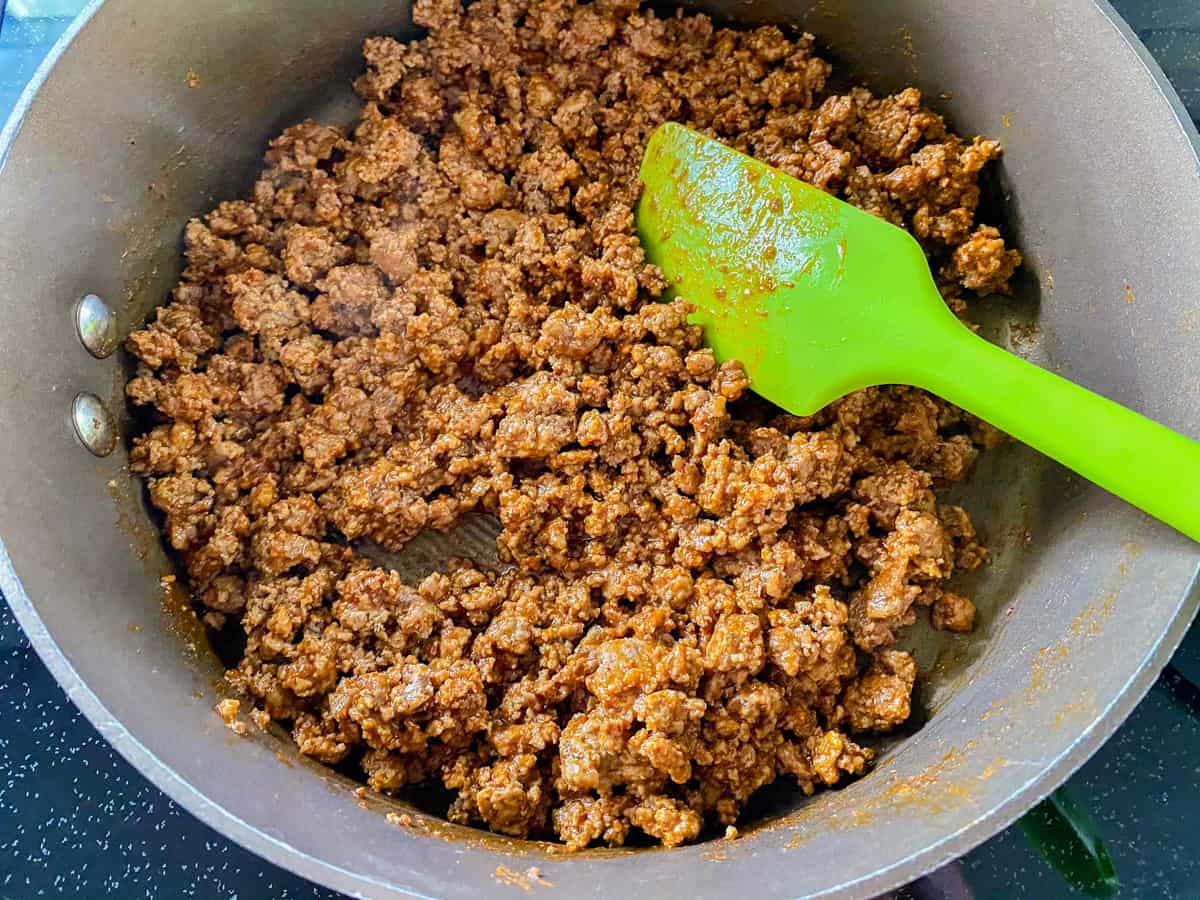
[0,0,1200,900]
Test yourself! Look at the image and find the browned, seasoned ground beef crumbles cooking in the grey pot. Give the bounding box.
[127,0,1019,848]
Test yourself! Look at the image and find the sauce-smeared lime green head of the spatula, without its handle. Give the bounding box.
[637,122,961,415]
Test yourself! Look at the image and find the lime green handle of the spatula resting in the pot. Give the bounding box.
[906,320,1200,540]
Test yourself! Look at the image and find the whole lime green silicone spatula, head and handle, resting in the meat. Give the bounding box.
[637,124,1200,540]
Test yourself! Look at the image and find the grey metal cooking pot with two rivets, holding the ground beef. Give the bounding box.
[0,0,1200,898]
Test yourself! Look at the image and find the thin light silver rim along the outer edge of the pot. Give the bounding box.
[0,0,1200,898]
